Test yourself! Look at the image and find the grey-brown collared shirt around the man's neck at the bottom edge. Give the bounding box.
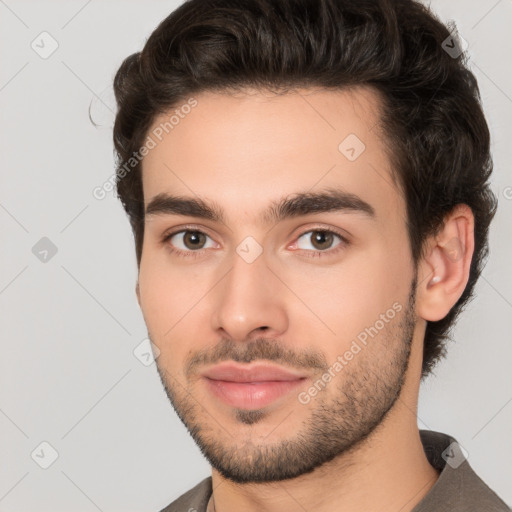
[160,430,511,512]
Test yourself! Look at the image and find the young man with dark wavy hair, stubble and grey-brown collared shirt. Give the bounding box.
[114,0,509,512]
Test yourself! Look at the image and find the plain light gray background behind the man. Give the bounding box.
[0,0,512,512]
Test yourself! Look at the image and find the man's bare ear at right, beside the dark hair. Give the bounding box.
[416,204,475,322]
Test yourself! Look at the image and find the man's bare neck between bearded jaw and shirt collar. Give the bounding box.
[212,416,438,512]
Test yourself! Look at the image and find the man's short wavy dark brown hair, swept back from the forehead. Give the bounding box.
[113,0,497,376]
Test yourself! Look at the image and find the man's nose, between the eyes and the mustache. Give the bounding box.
[212,246,288,342]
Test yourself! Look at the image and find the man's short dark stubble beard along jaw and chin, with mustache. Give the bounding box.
[152,277,416,483]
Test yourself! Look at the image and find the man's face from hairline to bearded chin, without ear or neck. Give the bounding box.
[137,89,416,482]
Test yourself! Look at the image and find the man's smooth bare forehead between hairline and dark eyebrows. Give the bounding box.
[142,88,404,226]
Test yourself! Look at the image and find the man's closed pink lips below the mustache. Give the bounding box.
[201,362,308,410]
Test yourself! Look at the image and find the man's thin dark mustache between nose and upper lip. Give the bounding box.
[185,338,329,377]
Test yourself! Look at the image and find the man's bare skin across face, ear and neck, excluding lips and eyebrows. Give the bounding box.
[136,88,474,512]
